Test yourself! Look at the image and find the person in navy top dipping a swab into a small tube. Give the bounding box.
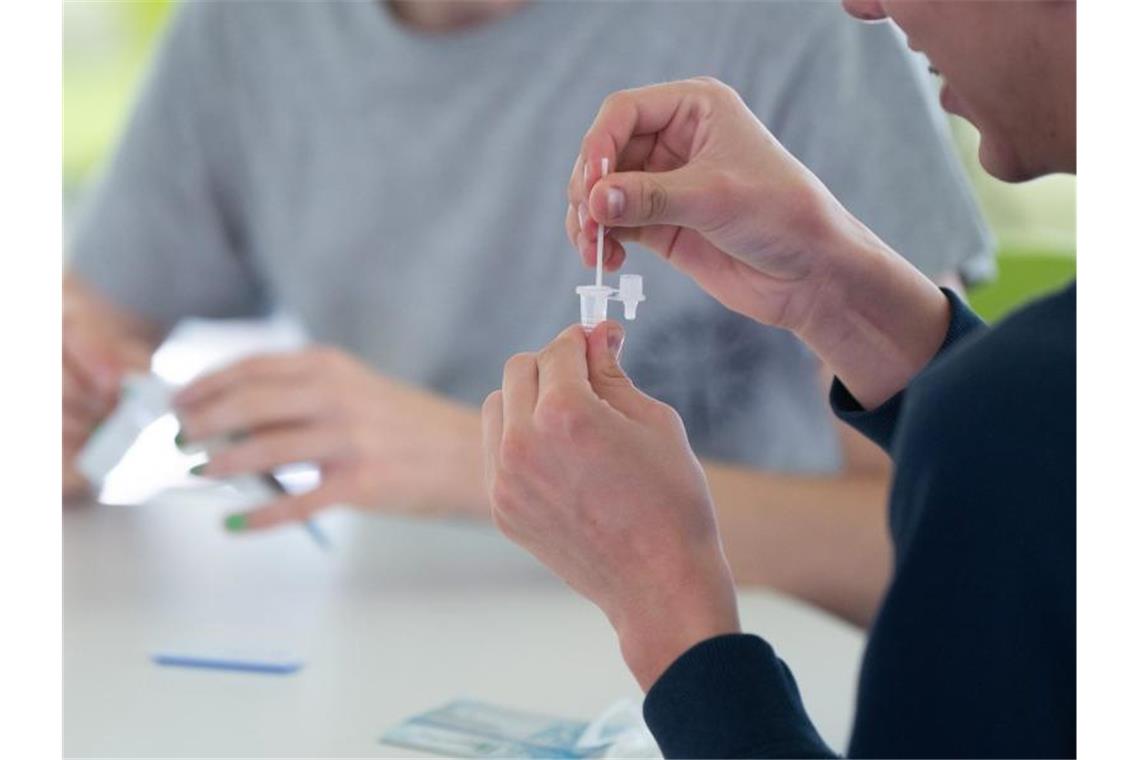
[483,0,1076,757]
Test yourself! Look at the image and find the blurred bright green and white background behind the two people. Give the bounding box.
[63,0,1076,319]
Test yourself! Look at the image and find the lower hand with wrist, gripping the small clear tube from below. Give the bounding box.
[482,321,740,689]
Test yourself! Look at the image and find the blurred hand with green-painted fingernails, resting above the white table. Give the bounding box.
[174,346,488,530]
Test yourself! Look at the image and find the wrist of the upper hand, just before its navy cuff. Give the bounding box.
[795,216,950,409]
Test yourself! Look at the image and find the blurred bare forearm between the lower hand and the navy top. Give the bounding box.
[703,461,891,627]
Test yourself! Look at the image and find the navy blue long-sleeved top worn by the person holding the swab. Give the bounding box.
[645,284,1076,758]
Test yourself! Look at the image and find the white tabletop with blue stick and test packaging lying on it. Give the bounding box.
[64,489,863,757]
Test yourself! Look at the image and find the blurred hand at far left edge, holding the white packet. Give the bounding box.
[63,281,153,499]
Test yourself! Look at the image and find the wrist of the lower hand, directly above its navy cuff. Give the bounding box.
[610,550,740,692]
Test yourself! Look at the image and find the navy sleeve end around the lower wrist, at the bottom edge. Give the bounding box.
[645,634,836,758]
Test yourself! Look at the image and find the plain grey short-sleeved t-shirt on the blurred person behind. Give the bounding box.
[71,2,992,472]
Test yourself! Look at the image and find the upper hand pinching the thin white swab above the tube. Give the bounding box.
[567,79,849,328]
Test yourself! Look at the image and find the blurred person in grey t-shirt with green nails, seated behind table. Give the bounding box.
[64,0,992,622]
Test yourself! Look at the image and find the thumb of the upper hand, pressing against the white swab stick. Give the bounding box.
[588,166,715,229]
